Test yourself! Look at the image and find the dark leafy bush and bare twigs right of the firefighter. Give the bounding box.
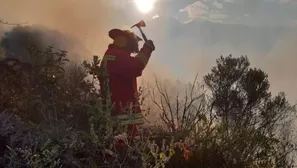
[149,55,296,168]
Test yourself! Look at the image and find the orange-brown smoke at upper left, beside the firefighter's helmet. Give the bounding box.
[0,0,123,60]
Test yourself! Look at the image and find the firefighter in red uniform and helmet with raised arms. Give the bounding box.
[100,29,155,137]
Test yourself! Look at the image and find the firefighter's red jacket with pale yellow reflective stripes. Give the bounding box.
[100,43,152,125]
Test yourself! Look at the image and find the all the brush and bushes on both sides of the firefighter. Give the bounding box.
[0,25,296,168]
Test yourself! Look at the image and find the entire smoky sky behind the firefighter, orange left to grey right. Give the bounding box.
[0,0,297,103]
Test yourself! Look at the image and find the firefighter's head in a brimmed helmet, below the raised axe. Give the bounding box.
[109,29,142,53]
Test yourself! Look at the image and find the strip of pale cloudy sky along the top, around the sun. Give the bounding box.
[103,0,297,26]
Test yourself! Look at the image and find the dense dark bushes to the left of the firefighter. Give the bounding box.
[0,44,170,168]
